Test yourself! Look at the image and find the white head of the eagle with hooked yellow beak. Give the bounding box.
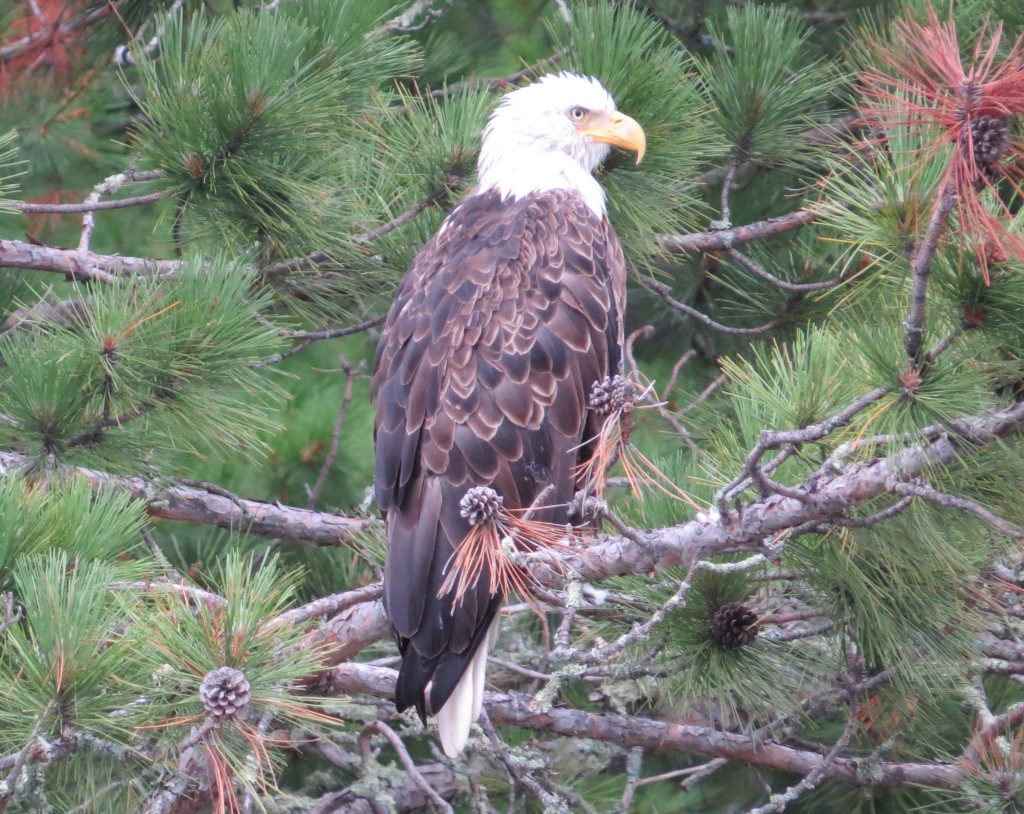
[477,73,647,217]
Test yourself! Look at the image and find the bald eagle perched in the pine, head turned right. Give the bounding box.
[371,73,646,757]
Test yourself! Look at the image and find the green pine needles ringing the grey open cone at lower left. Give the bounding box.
[132,552,330,799]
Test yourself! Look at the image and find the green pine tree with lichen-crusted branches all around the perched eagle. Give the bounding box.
[0,0,1024,814]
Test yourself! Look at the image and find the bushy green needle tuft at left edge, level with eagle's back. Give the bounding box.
[0,257,281,471]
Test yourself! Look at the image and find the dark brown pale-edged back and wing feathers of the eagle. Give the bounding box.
[373,190,625,716]
